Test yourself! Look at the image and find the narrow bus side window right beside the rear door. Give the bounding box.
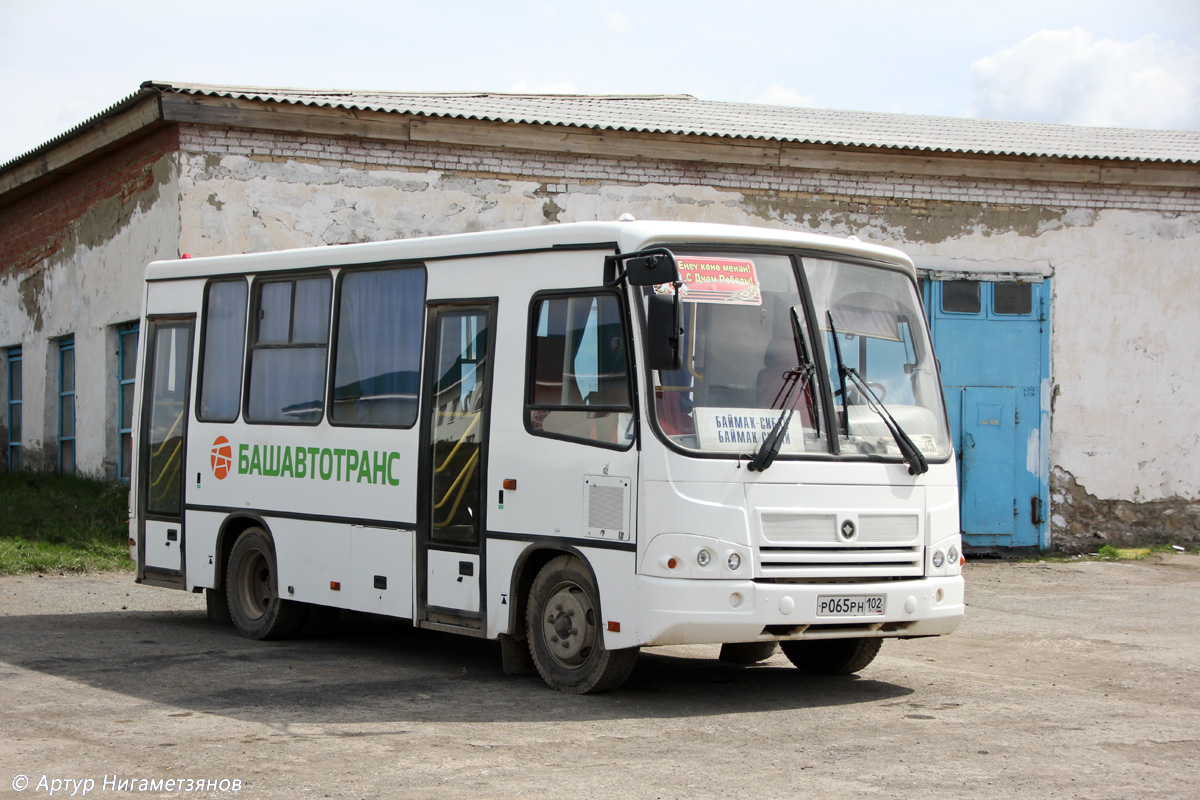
[196,278,246,422]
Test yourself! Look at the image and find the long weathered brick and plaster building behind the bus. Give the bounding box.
[0,83,1200,548]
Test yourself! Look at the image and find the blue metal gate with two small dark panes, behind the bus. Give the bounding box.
[925,279,1050,552]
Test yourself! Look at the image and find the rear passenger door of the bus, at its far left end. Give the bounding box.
[137,318,193,588]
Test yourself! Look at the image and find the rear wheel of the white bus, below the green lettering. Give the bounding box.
[226,528,307,639]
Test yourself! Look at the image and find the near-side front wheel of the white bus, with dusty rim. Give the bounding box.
[526,555,638,694]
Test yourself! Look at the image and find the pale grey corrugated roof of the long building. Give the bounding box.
[145,82,1200,163]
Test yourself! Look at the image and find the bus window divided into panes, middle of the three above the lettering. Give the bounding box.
[246,275,330,425]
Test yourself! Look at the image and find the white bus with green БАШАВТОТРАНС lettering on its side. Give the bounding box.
[130,221,964,693]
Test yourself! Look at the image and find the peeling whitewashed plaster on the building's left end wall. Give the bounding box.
[0,155,179,479]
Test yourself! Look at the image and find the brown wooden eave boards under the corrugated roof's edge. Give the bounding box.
[0,80,1200,204]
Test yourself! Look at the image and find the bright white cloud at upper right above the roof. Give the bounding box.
[968,28,1200,130]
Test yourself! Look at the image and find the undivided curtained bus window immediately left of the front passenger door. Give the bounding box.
[330,266,425,428]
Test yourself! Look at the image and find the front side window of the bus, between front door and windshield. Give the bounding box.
[526,294,632,447]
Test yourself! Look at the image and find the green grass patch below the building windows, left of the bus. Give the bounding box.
[0,473,133,575]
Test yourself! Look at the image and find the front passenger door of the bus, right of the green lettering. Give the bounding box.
[416,302,494,632]
